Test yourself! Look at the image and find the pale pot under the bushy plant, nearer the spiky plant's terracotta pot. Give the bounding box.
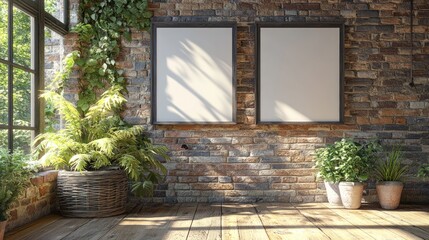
[339,182,363,209]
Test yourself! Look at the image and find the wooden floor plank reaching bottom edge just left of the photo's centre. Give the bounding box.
[188,203,222,240]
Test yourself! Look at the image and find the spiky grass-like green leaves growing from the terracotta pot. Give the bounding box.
[375,147,408,181]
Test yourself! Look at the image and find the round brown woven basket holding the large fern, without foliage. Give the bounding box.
[57,170,128,217]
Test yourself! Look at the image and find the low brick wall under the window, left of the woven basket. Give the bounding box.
[6,171,58,230]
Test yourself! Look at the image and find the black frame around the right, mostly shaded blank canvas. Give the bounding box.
[255,22,344,124]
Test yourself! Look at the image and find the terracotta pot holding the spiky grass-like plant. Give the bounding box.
[376,181,404,209]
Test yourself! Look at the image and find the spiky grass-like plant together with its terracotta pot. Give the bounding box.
[376,147,408,209]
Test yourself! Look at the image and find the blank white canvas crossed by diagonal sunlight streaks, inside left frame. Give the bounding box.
[155,27,235,123]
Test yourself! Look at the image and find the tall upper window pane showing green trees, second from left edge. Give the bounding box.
[13,7,33,68]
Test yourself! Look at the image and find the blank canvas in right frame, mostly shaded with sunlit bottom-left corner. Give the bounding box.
[259,27,341,122]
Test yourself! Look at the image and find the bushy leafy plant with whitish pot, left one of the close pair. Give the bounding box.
[316,142,343,205]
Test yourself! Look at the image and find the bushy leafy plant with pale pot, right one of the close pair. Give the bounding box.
[338,139,380,209]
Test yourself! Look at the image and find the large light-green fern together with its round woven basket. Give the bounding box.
[34,86,168,217]
